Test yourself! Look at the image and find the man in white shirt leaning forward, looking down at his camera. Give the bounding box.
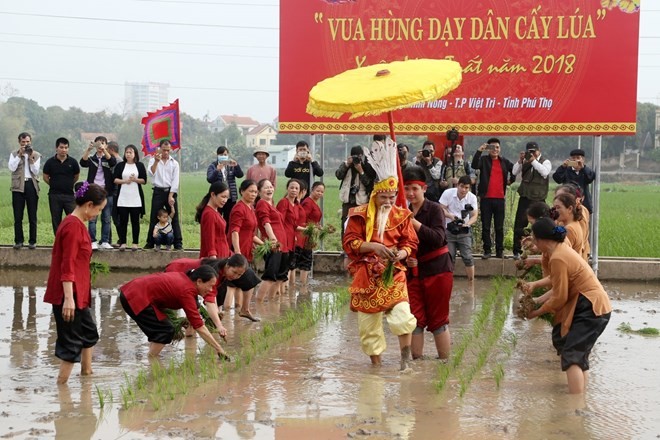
[440,176,479,281]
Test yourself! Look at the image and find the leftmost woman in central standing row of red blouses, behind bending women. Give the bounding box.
[195,181,231,258]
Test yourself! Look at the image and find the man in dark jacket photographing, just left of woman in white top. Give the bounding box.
[80,136,117,250]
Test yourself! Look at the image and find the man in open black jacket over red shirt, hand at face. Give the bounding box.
[472,138,515,259]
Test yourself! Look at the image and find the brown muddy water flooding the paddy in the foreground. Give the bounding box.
[0,272,660,439]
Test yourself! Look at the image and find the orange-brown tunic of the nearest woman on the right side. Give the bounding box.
[539,242,612,336]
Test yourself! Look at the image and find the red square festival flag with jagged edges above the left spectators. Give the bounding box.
[142,99,181,156]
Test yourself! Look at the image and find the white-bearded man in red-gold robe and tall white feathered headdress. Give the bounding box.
[343,139,418,370]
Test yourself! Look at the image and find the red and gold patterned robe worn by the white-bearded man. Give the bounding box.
[343,205,419,313]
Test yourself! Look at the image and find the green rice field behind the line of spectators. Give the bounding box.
[0,172,660,258]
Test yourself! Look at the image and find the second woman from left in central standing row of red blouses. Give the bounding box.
[225,179,263,321]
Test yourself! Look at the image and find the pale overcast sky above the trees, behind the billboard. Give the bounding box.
[0,0,660,122]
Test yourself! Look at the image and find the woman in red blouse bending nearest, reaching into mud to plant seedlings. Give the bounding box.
[119,265,235,361]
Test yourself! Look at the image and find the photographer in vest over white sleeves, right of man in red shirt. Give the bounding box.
[513,142,552,260]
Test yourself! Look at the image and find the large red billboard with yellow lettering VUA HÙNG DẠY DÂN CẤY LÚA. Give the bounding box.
[279,0,639,135]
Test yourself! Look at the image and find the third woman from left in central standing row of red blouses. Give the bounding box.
[255,179,289,301]
